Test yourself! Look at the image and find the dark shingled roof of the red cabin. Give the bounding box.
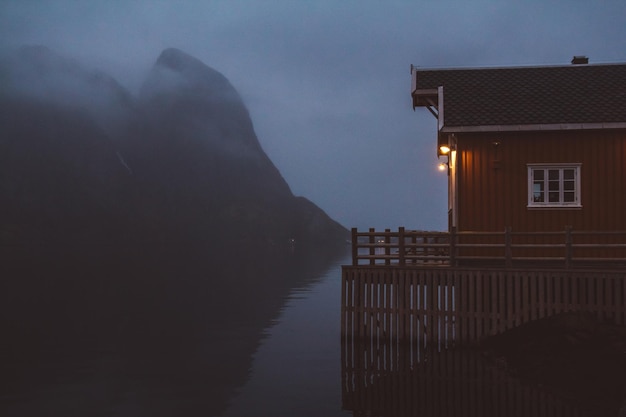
[413,64,626,128]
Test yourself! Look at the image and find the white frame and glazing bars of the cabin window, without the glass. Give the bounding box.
[526,163,582,209]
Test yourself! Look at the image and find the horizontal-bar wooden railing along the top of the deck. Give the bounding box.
[352,227,626,268]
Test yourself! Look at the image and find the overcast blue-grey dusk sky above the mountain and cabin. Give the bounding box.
[0,0,626,230]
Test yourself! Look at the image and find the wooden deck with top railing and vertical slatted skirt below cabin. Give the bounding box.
[342,228,626,347]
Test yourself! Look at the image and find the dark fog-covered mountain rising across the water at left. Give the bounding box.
[0,46,347,250]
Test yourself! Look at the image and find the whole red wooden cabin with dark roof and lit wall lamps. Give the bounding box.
[411,57,626,260]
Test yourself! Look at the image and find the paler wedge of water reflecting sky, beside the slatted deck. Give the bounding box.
[222,254,352,417]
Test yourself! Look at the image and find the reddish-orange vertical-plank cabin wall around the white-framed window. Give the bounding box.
[457,130,626,256]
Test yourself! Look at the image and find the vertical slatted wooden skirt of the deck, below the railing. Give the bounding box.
[341,266,626,344]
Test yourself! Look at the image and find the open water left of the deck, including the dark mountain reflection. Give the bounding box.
[0,249,352,416]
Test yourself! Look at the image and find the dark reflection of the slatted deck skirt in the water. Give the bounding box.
[341,337,598,417]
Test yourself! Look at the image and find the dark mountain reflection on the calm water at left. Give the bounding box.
[0,248,346,416]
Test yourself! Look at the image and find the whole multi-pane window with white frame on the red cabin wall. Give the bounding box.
[528,164,581,207]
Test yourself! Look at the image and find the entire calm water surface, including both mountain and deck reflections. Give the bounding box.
[0,245,621,417]
